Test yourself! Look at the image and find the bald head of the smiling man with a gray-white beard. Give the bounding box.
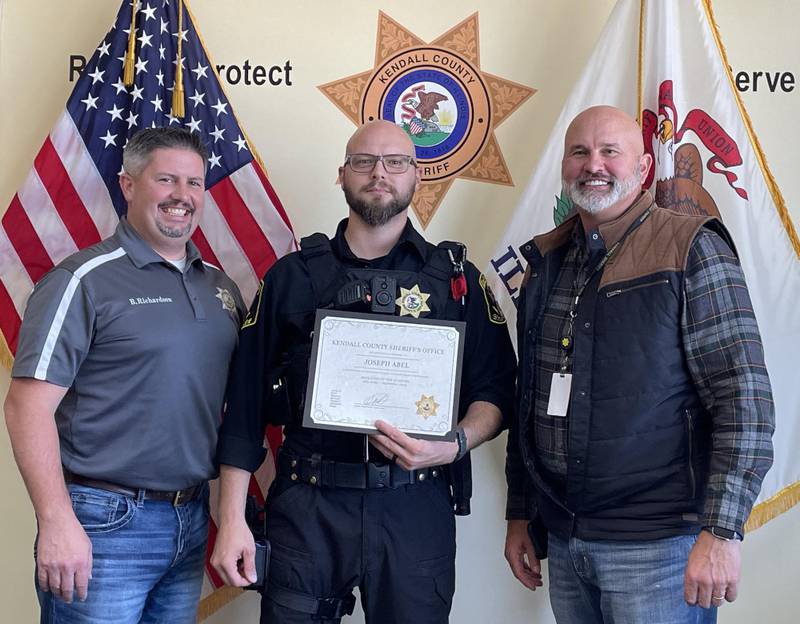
[561,106,653,225]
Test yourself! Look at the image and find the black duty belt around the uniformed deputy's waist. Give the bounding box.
[278,452,442,490]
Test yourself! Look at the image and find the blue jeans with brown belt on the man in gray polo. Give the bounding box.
[36,484,208,624]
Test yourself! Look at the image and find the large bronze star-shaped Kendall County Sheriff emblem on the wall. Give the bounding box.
[319,12,536,228]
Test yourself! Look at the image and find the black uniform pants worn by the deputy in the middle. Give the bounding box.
[261,475,456,624]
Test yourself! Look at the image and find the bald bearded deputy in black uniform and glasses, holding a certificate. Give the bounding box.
[212,121,515,624]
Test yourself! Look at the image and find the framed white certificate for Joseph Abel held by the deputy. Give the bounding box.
[303,310,466,440]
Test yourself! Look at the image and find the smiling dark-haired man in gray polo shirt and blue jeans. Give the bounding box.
[5,128,243,623]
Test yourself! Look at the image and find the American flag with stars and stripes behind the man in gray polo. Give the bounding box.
[0,0,296,615]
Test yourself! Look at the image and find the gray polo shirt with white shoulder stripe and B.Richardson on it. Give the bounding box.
[11,218,244,490]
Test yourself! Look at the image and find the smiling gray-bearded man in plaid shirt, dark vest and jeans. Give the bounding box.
[505,106,774,624]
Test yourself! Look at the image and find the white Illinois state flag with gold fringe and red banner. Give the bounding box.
[486,0,800,529]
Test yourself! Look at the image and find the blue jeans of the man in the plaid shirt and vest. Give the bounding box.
[548,533,717,624]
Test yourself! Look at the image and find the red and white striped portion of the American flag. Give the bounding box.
[0,110,297,354]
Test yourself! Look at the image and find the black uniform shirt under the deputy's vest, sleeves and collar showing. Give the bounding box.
[217,219,516,472]
